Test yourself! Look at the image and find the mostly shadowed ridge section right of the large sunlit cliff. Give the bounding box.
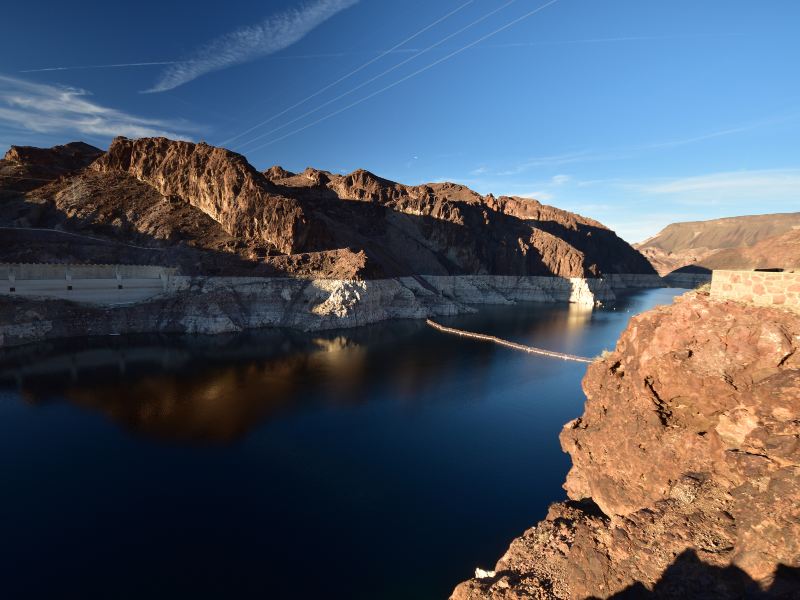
[266,161,653,277]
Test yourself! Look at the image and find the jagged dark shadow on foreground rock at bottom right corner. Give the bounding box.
[600,550,800,600]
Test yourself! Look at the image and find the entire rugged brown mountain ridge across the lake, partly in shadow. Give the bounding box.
[0,138,653,278]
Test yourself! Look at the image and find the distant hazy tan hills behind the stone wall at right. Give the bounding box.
[634,212,800,275]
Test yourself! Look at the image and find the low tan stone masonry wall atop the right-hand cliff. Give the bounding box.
[711,271,800,312]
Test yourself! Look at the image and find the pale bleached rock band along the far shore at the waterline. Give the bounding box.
[0,275,669,348]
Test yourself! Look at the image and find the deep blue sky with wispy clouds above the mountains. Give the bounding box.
[0,0,800,241]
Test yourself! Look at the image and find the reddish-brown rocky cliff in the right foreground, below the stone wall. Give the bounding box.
[452,293,800,600]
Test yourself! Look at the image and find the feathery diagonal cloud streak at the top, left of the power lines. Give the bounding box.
[147,0,358,92]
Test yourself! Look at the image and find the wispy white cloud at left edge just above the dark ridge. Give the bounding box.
[0,75,190,139]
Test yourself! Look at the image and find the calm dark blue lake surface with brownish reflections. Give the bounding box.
[0,290,683,599]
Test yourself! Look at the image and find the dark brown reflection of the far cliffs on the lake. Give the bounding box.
[0,305,608,443]
